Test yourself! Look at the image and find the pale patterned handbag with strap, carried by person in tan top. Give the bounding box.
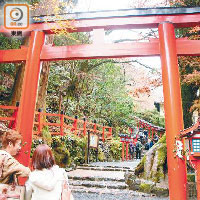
[0,156,25,200]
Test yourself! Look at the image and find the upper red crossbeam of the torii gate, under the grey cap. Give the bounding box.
[0,13,200,34]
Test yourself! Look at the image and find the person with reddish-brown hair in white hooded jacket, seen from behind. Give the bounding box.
[25,144,68,200]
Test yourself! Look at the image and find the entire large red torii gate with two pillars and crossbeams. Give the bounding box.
[0,7,200,200]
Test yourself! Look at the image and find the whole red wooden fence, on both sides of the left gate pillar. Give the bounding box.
[0,105,112,142]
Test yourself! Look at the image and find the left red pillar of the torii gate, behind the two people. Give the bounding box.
[17,31,45,166]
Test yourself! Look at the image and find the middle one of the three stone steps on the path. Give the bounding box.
[68,175,125,182]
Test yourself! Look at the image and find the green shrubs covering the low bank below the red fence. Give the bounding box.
[31,134,122,167]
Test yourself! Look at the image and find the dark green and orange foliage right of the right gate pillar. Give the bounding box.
[172,0,200,128]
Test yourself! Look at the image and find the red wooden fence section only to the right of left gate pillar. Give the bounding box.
[33,112,112,142]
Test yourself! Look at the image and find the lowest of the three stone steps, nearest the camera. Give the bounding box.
[69,180,128,190]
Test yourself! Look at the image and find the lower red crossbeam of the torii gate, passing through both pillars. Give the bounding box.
[0,39,200,63]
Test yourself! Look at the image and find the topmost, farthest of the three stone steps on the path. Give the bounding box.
[77,166,134,172]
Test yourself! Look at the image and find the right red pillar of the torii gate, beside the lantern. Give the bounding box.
[158,22,187,200]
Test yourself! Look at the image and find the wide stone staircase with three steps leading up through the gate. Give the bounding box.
[68,160,148,196]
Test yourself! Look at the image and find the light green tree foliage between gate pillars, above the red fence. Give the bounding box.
[47,57,134,134]
